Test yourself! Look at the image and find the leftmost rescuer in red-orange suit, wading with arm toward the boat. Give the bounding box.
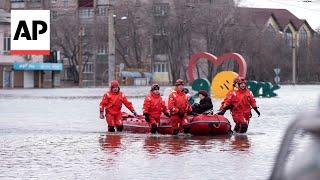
[100,80,137,132]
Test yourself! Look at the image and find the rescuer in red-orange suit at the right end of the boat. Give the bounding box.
[217,77,260,133]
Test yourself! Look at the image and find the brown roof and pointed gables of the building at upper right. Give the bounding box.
[239,7,314,47]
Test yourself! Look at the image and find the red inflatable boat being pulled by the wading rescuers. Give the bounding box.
[122,113,231,135]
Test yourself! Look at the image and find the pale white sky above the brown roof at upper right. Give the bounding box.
[240,0,320,29]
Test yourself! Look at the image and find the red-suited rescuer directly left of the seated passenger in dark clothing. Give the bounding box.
[168,79,192,135]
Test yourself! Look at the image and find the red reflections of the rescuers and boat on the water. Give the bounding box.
[99,133,251,157]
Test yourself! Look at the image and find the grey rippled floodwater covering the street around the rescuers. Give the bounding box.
[0,85,320,180]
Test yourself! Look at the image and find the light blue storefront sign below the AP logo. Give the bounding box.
[13,62,63,71]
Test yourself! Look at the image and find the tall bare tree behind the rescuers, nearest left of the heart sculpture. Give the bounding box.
[153,1,200,82]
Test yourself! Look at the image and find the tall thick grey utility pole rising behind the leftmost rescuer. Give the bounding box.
[108,0,116,85]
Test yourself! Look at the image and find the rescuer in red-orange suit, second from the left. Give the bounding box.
[143,84,170,134]
